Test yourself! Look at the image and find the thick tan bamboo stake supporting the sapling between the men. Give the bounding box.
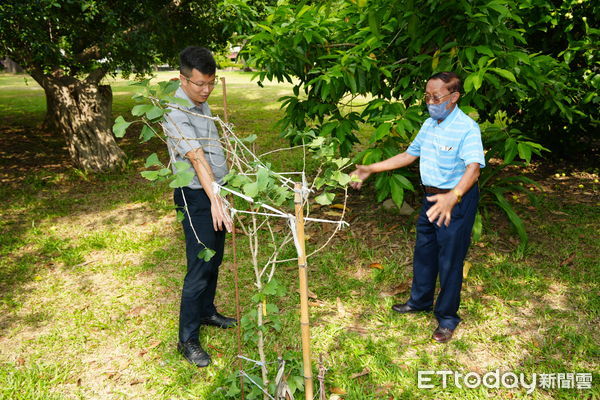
[294,183,313,400]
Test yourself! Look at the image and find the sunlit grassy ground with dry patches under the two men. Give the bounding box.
[0,73,600,400]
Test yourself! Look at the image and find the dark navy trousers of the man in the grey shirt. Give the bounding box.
[173,187,225,342]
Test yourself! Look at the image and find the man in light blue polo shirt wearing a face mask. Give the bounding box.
[351,72,485,343]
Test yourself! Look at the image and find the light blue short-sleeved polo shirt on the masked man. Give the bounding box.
[406,106,485,189]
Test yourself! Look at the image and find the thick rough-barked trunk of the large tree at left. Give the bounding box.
[36,75,125,172]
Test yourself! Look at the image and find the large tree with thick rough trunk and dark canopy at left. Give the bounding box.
[0,0,236,171]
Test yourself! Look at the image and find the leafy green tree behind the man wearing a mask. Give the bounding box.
[241,0,600,247]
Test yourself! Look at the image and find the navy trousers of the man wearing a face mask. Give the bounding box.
[408,184,479,329]
